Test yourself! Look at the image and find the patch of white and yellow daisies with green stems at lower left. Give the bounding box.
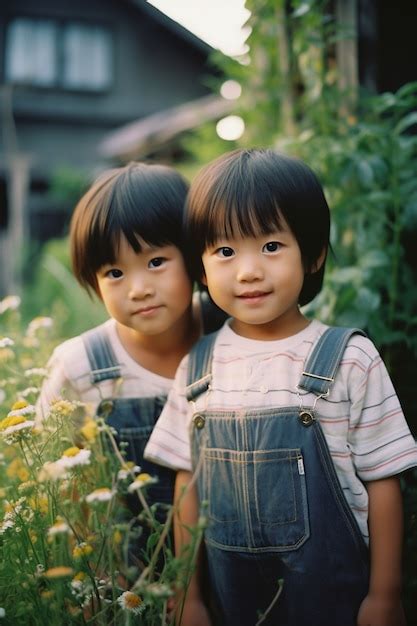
[0,296,205,626]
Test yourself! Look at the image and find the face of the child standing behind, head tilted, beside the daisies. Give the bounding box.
[97,235,192,335]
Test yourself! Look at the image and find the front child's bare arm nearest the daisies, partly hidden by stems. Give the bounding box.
[174,470,211,626]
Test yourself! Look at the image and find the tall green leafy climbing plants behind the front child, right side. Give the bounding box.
[183,0,417,616]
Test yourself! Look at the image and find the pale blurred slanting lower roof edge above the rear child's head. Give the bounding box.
[98,95,235,160]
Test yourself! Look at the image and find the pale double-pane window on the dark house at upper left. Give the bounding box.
[5,18,112,91]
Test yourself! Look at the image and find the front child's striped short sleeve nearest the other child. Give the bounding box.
[144,356,191,471]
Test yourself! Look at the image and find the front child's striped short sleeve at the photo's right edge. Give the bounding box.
[348,339,417,482]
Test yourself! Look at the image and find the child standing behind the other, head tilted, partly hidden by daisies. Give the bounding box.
[38,163,224,528]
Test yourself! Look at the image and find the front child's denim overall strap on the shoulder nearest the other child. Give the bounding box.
[186,332,217,401]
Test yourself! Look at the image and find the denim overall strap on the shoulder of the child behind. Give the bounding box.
[81,328,121,384]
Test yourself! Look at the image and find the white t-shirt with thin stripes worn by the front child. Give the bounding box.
[145,321,417,540]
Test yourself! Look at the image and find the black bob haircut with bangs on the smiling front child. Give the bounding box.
[185,148,330,305]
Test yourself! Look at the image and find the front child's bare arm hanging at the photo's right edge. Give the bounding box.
[357,476,405,626]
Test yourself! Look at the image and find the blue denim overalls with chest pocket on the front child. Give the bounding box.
[187,328,369,626]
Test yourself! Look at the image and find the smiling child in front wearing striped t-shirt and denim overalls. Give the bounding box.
[145,149,417,626]
